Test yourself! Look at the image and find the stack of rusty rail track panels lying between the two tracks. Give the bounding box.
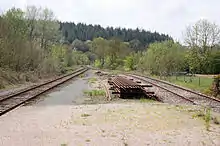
[108,76,154,98]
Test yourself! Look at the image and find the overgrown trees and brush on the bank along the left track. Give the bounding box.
[0,6,89,88]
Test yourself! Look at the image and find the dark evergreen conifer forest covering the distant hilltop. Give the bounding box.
[60,22,172,51]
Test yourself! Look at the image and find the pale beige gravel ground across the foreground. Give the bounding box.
[0,102,220,146]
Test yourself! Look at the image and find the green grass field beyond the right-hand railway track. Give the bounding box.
[154,76,213,94]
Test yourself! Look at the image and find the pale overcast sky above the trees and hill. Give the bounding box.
[0,0,220,41]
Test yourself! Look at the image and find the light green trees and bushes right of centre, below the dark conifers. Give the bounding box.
[87,20,220,76]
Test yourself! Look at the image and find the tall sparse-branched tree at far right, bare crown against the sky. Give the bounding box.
[185,20,220,73]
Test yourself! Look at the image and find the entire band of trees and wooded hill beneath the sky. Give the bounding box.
[0,6,220,91]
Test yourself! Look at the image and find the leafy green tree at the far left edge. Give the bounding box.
[0,8,29,71]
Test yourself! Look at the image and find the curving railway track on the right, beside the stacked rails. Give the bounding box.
[129,75,220,112]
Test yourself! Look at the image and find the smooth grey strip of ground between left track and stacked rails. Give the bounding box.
[34,71,94,106]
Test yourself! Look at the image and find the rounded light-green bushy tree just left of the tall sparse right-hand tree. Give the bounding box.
[143,41,184,76]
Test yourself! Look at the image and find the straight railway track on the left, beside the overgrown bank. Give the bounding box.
[0,68,88,116]
